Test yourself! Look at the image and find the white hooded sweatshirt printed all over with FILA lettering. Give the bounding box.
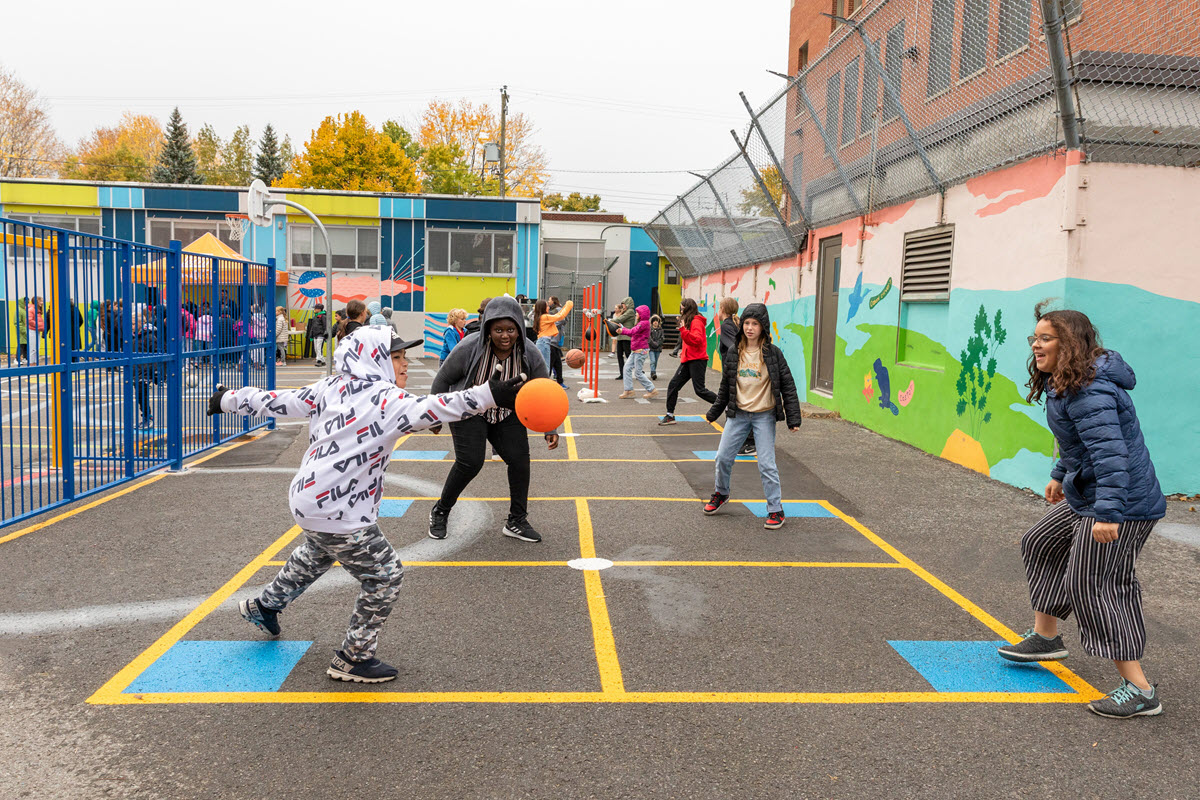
[221,327,496,534]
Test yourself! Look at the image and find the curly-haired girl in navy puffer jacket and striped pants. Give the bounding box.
[1000,302,1166,717]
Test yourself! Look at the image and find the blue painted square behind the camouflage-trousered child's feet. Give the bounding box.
[125,642,312,694]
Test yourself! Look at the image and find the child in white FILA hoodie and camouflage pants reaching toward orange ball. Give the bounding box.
[209,327,524,684]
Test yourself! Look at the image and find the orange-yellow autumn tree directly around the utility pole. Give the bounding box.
[418,100,550,197]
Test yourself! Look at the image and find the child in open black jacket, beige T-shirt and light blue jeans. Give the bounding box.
[704,302,800,530]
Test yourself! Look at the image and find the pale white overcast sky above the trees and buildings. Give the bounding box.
[0,0,790,222]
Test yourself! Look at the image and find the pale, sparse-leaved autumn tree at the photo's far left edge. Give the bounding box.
[0,67,64,178]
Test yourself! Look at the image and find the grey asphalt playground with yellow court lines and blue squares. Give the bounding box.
[0,360,1200,798]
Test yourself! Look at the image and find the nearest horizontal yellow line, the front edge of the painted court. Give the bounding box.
[88,688,1087,705]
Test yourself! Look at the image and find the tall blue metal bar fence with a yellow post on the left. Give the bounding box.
[0,218,275,528]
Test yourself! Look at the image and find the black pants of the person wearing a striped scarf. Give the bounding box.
[438,414,529,522]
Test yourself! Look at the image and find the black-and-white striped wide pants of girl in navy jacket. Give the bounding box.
[1021,500,1158,661]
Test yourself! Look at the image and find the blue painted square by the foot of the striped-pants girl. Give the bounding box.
[888,642,1074,693]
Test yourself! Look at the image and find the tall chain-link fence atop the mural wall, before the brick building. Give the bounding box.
[646,0,1200,276]
